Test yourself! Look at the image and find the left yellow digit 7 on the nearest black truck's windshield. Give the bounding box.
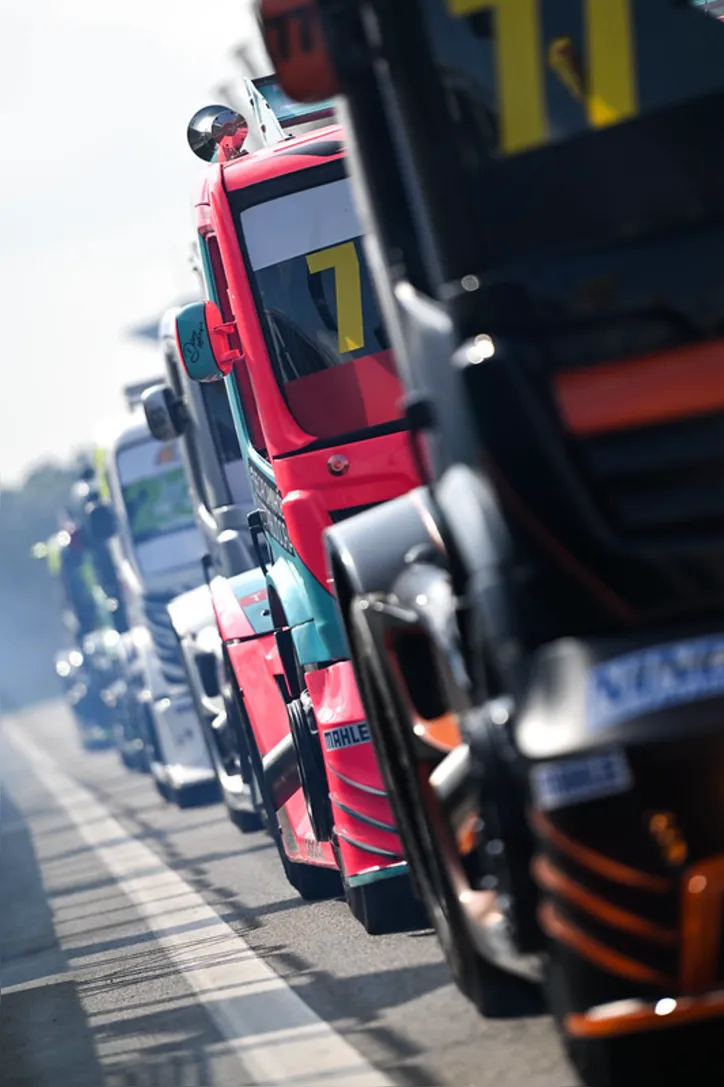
[447,0,547,154]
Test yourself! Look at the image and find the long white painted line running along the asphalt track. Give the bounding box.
[7,726,392,1087]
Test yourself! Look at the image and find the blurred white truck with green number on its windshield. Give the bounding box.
[98,382,216,808]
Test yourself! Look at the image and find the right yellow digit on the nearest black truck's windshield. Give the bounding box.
[586,0,637,128]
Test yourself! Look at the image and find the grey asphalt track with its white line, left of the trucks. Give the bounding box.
[0,703,575,1087]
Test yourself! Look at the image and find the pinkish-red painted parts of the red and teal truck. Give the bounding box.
[197,126,419,875]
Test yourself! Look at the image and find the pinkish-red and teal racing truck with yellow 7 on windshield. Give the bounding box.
[171,77,424,932]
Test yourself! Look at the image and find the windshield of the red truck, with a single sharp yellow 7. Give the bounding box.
[236,171,400,439]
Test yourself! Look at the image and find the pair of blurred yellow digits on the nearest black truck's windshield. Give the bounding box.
[447,0,637,154]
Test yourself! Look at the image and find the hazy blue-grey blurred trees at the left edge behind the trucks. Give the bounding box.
[0,463,76,713]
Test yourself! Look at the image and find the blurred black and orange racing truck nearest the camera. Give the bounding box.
[263,0,724,1087]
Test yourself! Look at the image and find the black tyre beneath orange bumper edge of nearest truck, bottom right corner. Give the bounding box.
[546,948,724,1087]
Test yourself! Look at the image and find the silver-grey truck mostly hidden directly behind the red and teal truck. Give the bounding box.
[141,293,261,832]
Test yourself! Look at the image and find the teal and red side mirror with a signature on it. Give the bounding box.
[176,302,242,382]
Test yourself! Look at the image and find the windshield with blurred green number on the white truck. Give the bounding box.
[117,440,195,545]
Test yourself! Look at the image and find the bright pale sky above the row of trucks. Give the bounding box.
[0,0,269,486]
